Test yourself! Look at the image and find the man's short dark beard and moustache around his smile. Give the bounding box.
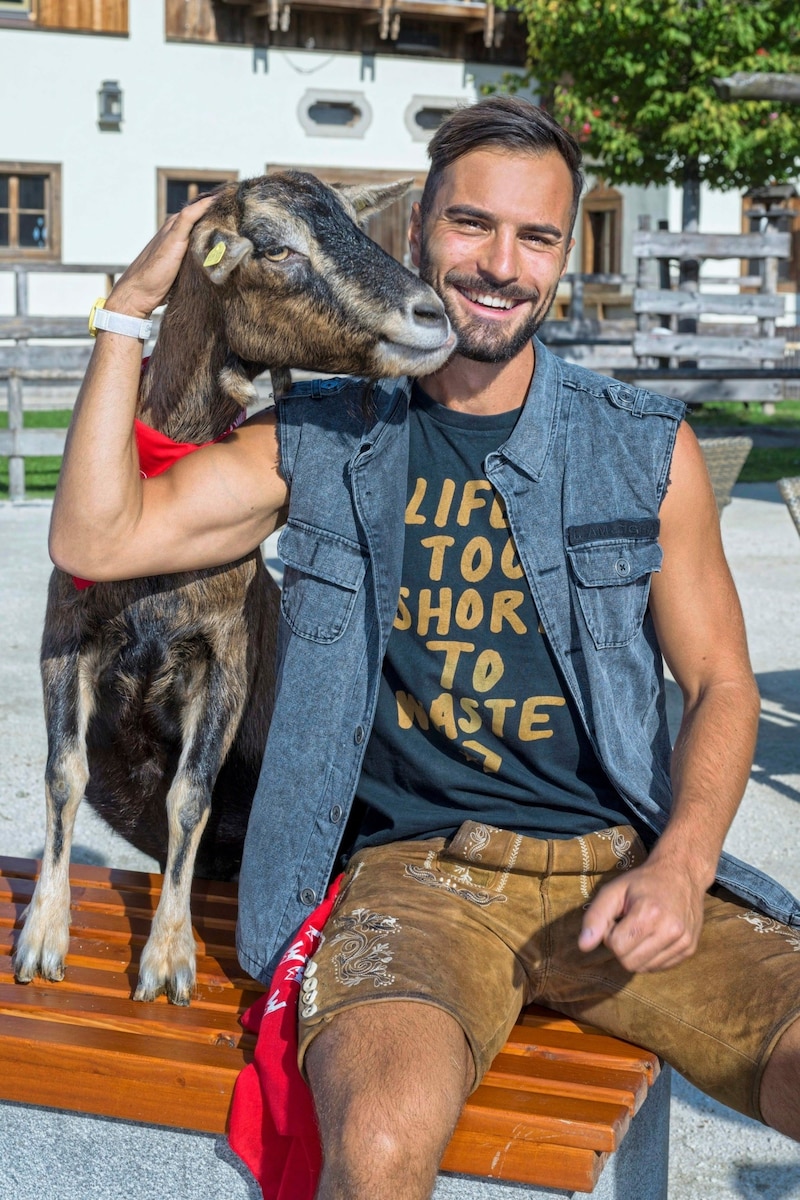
[420,244,558,362]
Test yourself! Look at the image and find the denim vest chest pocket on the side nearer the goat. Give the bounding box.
[277,518,367,643]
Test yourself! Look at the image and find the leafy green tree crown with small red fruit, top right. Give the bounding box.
[504,0,800,229]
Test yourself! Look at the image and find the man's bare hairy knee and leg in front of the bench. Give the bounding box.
[306,1001,475,1200]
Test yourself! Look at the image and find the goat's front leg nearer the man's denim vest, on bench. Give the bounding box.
[133,662,242,1004]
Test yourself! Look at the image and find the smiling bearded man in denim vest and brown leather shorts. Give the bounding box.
[52,97,800,1200]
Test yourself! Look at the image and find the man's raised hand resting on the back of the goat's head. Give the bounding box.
[106,196,215,317]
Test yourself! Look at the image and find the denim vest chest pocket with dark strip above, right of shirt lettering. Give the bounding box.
[566,538,663,649]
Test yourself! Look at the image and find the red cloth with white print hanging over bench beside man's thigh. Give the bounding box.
[228,875,342,1200]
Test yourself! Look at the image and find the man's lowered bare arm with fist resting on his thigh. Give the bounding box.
[579,425,759,972]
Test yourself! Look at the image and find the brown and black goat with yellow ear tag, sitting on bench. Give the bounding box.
[14,172,455,1004]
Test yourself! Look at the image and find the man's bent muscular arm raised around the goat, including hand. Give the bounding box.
[50,199,287,581]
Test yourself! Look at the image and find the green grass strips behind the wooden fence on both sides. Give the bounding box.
[0,400,800,500]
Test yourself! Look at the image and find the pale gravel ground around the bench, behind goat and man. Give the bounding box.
[0,484,800,1200]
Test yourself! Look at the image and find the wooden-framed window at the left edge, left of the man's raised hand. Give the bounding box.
[0,162,61,262]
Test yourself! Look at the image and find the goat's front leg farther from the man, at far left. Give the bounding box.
[14,654,95,983]
